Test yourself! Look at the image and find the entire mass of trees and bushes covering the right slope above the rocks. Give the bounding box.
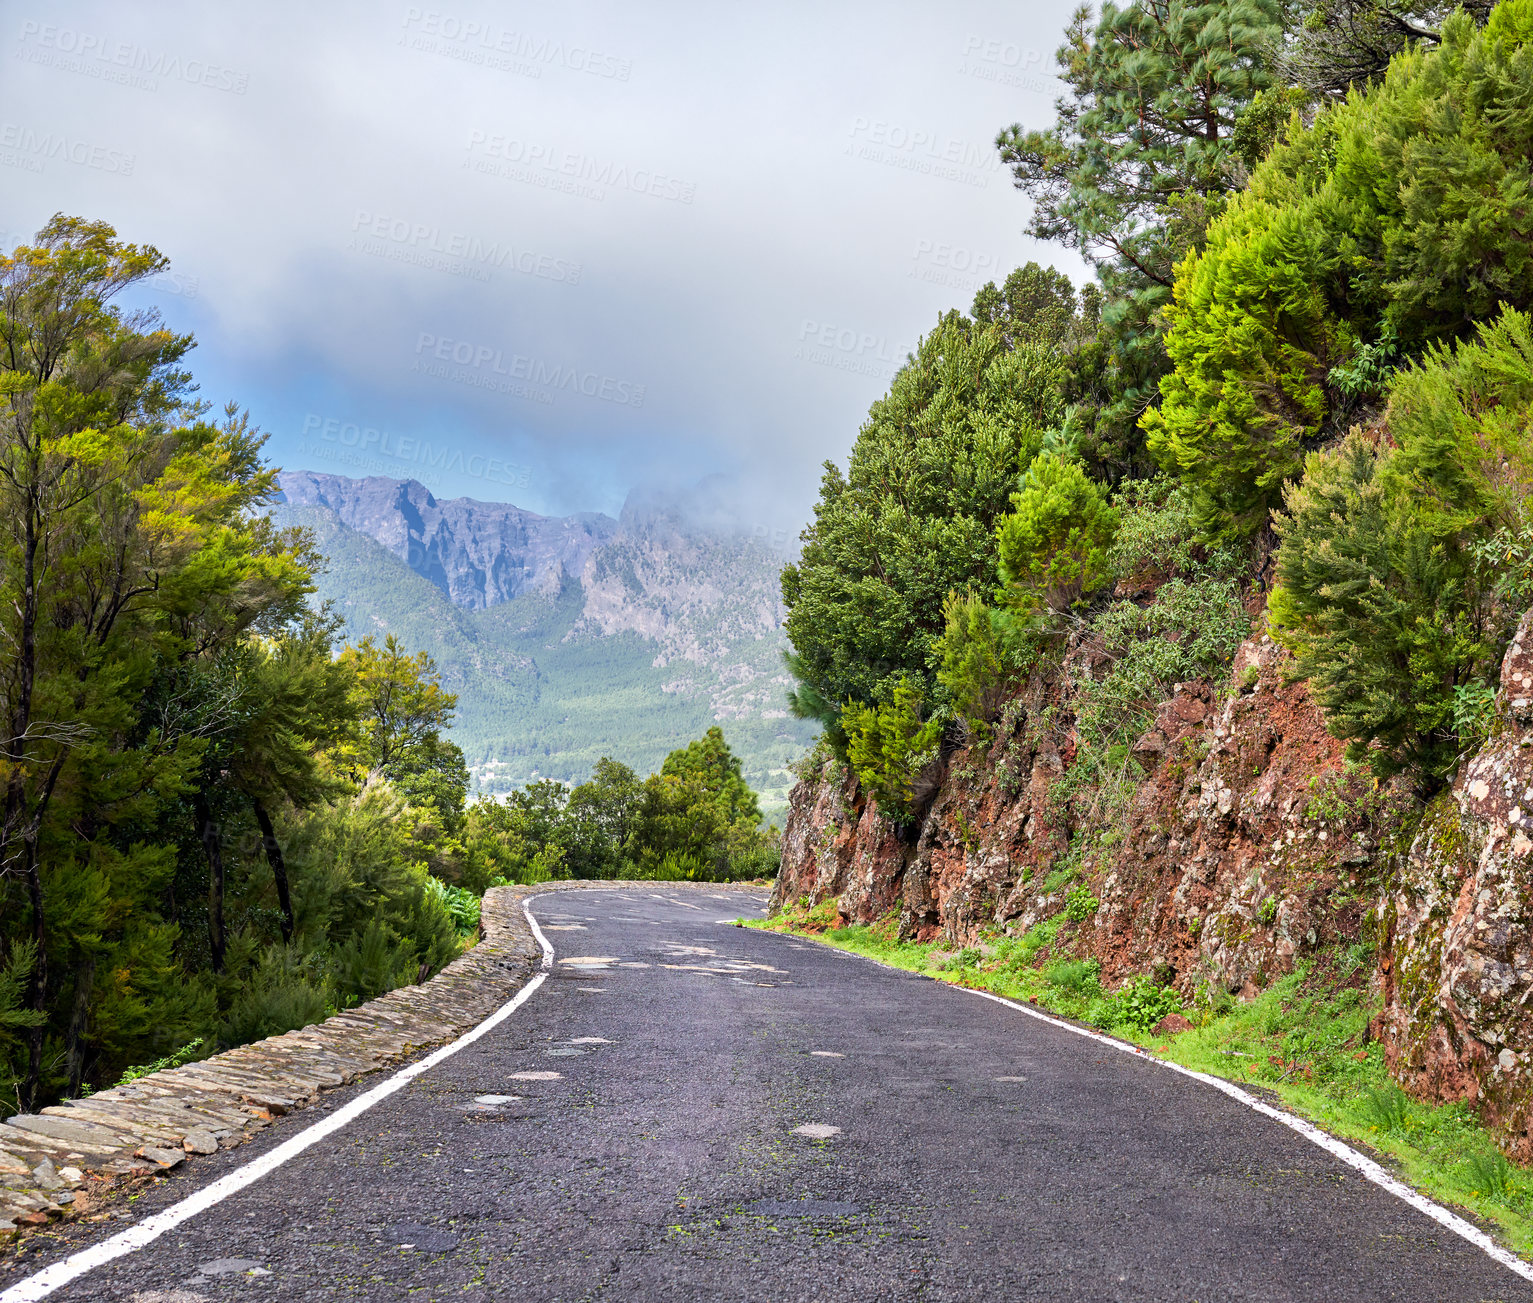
[785,0,1533,821]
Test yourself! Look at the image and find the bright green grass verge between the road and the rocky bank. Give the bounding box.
[740,900,1533,1257]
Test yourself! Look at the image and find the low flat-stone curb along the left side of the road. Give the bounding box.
[0,880,759,1245]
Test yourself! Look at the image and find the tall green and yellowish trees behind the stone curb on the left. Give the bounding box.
[0,218,481,1105]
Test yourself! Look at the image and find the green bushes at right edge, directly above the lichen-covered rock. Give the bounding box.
[1269,311,1533,789]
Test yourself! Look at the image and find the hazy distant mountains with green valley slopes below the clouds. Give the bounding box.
[273,471,814,811]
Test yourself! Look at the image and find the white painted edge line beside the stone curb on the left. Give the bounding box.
[0,900,553,1303]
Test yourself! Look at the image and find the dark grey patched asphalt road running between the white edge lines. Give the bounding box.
[0,891,1533,1303]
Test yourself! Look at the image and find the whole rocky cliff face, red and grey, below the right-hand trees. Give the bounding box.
[774,613,1533,1159]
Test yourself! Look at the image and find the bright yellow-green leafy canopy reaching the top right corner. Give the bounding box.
[1144,0,1533,535]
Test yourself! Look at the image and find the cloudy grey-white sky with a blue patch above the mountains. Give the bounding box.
[0,0,1082,537]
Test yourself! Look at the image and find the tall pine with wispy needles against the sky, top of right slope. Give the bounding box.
[996,0,1283,450]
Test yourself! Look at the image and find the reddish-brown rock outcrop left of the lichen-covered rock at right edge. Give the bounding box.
[776,635,1400,996]
